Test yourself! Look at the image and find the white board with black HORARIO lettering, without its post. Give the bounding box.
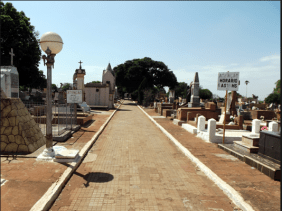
[217,72,239,91]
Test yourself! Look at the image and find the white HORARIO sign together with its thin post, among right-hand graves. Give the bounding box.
[217,71,239,144]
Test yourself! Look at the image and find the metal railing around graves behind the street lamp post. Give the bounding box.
[24,102,77,136]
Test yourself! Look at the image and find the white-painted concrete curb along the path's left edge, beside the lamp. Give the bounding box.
[30,101,124,211]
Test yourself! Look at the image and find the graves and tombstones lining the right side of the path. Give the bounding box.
[154,72,281,180]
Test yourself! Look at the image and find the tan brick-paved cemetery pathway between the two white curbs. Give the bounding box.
[50,101,235,211]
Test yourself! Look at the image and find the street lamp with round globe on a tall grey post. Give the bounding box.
[40,32,63,157]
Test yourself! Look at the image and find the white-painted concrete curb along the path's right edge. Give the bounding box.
[137,105,254,211]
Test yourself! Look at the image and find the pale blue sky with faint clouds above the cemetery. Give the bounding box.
[4,1,281,100]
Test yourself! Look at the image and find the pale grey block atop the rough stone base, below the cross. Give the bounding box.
[1,66,19,98]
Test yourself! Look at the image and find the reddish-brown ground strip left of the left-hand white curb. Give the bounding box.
[1,110,114,211]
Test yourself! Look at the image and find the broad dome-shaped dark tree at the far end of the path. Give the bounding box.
[113,57,177,99]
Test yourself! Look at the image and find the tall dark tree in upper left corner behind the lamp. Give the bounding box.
[0,2,46,88]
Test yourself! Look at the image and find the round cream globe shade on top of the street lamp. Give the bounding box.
[40,32,63,54]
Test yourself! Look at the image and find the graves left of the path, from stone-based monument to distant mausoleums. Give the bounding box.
[0,49,119,162]
